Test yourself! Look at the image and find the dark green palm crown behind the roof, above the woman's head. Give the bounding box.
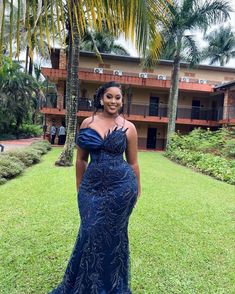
[80,27,130,56]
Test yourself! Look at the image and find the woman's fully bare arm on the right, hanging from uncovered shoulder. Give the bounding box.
[126,122,141,198]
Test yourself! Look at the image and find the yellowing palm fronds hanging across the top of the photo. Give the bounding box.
[0,0,171,64]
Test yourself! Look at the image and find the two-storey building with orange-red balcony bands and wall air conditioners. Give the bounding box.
[41,49,235,150]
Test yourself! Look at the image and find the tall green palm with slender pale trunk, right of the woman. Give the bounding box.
[146,0,232,148]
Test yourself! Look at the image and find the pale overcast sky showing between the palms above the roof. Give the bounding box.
[118,0,235,67]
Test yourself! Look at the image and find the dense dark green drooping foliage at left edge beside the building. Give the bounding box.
[0,59,42,138]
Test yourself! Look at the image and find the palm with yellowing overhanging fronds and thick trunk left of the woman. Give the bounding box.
[0,0,171,165]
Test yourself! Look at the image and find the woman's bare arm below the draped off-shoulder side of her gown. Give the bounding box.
[76,146,89,192]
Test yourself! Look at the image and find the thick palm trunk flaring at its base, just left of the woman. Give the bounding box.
[55,12,80,166]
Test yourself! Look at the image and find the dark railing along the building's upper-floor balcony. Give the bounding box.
[44,94,235,121]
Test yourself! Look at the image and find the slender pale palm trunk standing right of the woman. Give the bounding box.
[166,54,180,149]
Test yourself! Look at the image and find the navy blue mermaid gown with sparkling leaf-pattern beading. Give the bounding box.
[50,127,138,294]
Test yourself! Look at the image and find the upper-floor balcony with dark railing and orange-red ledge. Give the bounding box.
[42,94,235,126]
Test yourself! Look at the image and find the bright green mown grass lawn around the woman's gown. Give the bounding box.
[0,148,235,294]
